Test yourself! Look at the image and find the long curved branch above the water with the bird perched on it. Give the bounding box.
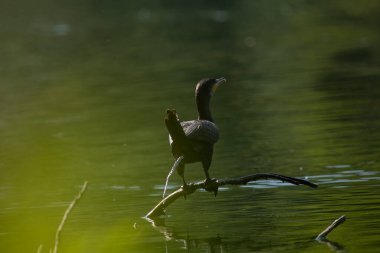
[145,173,318,218]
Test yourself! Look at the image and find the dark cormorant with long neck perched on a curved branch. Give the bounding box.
[165,77,226,196]
